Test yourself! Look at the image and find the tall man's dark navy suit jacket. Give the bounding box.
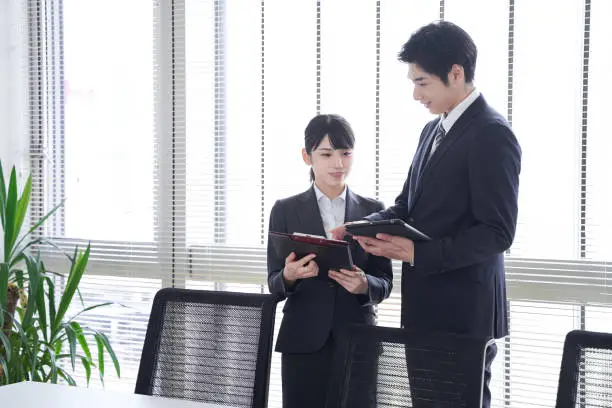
[366,95,521,338]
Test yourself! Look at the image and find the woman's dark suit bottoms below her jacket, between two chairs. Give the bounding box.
[281,336,335,408]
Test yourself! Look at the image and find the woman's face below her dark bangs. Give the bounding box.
[302,136,353,188]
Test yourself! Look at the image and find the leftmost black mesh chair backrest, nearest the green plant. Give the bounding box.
[135,288,277,408]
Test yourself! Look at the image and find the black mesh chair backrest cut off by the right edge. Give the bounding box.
[556,330,612,408]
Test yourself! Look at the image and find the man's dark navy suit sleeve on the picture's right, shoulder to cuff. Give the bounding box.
[414,124,521,273]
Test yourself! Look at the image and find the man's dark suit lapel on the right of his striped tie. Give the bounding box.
[409,95,485,212]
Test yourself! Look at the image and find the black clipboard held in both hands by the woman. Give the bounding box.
[268,231,353,278]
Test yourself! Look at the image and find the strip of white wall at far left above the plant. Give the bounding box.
[0,0,29,175]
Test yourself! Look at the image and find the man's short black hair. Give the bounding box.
[398,21,478,85]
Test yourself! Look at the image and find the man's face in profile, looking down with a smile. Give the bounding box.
[408,63,457,115]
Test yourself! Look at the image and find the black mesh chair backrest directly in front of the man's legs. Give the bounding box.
[326,325,493,408]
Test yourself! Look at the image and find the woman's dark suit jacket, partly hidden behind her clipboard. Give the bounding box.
[268,188,393,353]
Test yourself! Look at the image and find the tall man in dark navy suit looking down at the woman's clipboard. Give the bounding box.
[333,22,521,407]
